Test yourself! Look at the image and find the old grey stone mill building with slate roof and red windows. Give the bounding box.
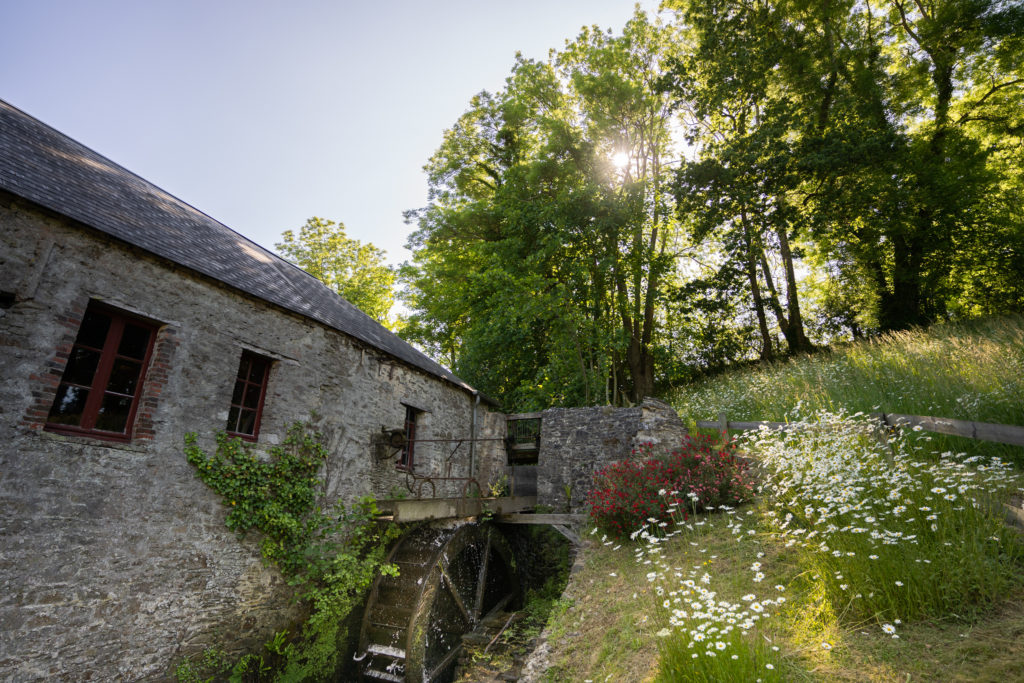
[0,101,505,681]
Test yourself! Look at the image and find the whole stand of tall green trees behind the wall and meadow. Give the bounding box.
[400,0,1024,403]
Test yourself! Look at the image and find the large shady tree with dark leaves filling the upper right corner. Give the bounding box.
[672,0,1024,331]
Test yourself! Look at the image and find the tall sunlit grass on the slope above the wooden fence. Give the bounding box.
[671,316,1024,464]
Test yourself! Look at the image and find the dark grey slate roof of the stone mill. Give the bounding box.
[0,99,473,391]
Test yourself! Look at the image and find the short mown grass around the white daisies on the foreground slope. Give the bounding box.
[544,508,1024,683]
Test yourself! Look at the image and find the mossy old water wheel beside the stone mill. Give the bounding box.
[356,523,518,683]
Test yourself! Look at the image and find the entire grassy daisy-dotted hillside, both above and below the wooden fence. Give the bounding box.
[546,318,1024,682]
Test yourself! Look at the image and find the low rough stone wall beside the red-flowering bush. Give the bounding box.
[537,398,686,511]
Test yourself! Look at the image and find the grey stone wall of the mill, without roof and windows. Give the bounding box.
[0,200,505,681]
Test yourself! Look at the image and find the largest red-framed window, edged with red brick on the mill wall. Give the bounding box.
[46,303,157,441]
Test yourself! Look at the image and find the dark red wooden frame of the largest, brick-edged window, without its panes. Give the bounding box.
[44,302,160,442]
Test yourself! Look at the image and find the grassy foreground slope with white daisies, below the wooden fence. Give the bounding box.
[547,414,1024,683]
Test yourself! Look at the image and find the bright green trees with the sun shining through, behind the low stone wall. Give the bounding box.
[401,12,679,411]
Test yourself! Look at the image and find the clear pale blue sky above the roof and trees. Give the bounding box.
[0,0,657,263]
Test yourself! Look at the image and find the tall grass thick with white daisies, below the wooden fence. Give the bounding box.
[632,412,1024,683]
